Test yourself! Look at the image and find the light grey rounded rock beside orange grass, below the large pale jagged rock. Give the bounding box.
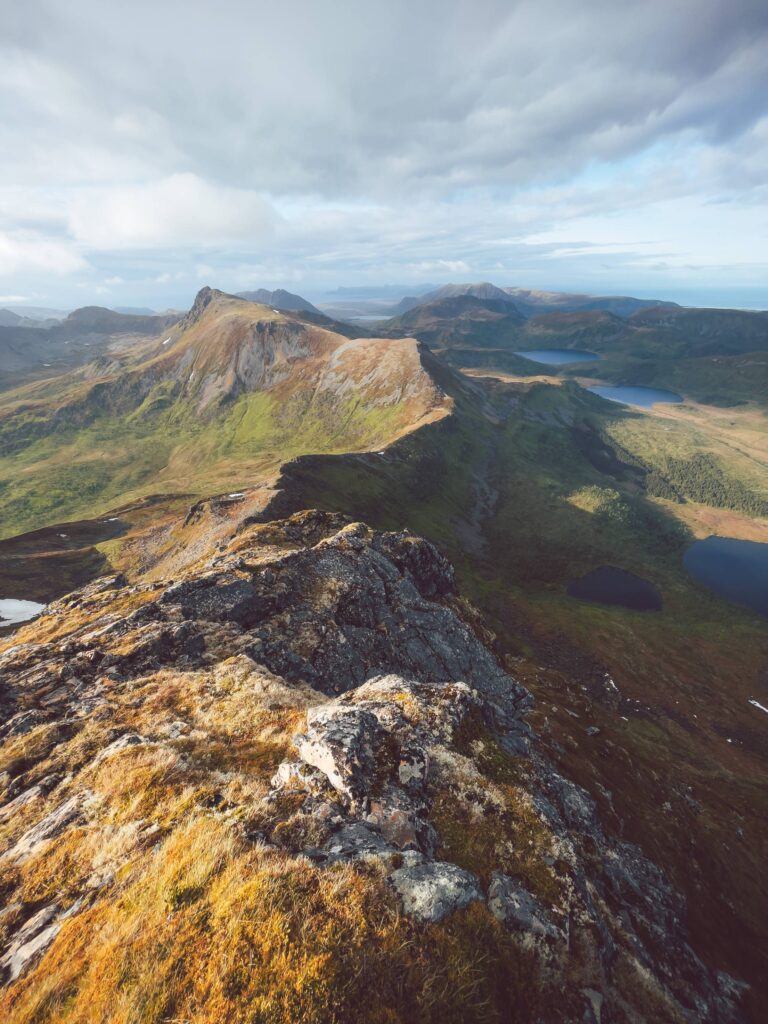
[389,861,482,922]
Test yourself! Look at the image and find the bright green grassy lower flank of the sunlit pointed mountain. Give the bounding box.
[0,385,423,537]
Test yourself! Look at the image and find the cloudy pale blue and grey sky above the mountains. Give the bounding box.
[0,0,768,309]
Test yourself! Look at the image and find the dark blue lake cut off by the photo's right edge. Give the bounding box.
[683,537,768,618]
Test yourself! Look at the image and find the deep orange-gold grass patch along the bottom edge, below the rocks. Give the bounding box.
[0,816,557,1024]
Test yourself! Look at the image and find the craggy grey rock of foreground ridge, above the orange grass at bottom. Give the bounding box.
[0,512,753,1024]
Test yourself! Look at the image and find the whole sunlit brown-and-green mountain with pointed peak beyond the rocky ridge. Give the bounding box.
[0,289,450,537]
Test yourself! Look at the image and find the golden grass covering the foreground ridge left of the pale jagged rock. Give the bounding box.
[0,656,573,1024]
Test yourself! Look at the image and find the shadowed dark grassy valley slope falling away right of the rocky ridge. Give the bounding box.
[264,372,768,1003]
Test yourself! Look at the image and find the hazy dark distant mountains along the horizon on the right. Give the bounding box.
[385,284,768,406]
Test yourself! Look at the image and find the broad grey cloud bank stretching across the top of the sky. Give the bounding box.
[0,0,768,198]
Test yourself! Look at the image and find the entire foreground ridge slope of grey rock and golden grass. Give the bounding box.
[0,512,741,1024]
